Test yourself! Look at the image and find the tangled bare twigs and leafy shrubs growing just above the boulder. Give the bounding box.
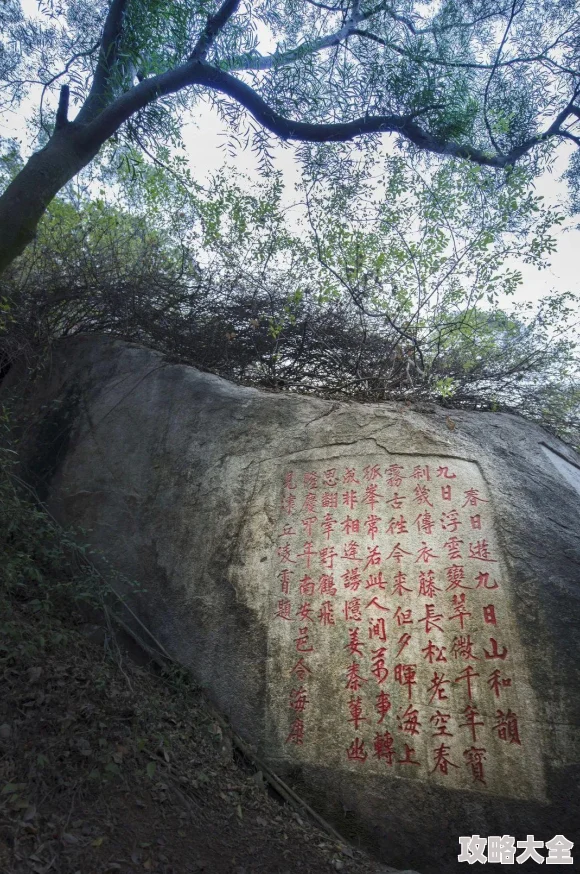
[0,148,579,442]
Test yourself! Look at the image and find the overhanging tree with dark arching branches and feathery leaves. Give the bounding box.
[0,0,580,270]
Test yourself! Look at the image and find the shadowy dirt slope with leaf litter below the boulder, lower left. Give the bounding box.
[0,585,414,874]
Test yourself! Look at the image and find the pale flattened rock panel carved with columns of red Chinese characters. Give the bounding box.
[269,456,534,794]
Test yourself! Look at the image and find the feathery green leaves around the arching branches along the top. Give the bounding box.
[0,0,580,181]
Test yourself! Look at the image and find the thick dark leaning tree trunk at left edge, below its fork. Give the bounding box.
[0,125,98,274]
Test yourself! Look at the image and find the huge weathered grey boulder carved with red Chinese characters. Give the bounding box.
[5,337,580,874]
